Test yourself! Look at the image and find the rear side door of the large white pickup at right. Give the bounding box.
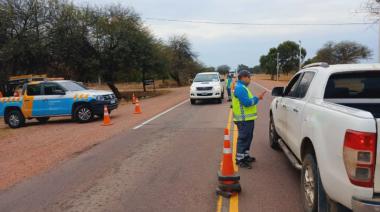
[283,71,315,152]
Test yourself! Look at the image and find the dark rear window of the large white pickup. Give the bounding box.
[324,71,380,99]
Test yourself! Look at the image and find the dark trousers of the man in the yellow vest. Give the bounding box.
[235,121,255,161]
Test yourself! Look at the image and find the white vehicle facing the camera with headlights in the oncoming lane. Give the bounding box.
[190,72,224,104]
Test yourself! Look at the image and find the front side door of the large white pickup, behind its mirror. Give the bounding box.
[274,74,301,140]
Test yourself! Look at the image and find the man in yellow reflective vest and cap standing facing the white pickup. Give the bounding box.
[232,70,266,169]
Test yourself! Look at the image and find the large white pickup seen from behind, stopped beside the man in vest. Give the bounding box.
[270,63,380,211]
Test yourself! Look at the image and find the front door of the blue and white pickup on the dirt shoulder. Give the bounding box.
[43,82,71,116]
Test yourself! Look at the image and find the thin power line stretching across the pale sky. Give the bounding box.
[145,18,376,26]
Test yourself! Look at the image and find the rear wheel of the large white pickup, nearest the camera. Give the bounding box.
[301,153,329,212]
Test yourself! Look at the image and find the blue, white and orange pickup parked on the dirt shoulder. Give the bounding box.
[0,80,118,128]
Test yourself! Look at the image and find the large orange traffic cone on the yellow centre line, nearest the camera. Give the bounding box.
[216,129,241,198]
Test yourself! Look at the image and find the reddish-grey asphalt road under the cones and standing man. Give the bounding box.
[0,82,301,212]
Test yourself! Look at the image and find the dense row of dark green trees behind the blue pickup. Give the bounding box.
[0,0,204,88]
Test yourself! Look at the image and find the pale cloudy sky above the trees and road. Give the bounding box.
[73,0,380,68]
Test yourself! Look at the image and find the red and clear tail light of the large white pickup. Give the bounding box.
[343,130,377,188]
